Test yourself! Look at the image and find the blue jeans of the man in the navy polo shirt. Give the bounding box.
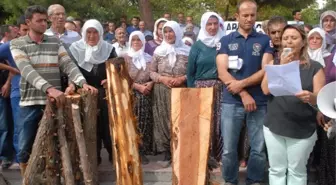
[221,103,266,185]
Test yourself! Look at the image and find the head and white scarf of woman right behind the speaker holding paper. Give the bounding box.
[308,28,330,67]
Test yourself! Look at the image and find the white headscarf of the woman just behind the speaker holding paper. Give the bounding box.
[308,28,330,67]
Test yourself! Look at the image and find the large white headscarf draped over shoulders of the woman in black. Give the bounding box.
[70,19,113,72]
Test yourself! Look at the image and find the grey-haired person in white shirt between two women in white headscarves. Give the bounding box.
[113,28,129,57]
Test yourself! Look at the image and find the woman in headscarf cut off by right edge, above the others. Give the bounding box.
[320,10,336,52]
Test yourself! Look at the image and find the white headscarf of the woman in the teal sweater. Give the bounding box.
[197,12,225,48]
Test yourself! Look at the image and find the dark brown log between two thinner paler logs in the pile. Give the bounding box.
[64,94,82,181]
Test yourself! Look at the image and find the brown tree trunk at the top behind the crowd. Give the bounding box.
[139,0,154,31]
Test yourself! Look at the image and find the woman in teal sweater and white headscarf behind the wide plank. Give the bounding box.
[187,12,225,165]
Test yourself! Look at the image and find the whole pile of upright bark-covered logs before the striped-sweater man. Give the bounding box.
[23,92,99,185]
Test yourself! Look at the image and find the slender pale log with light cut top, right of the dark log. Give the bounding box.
[72,103,93,185]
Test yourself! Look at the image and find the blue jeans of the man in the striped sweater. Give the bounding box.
[17,105,45,163]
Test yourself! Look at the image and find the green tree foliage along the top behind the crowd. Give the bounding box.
[0,0,318,23]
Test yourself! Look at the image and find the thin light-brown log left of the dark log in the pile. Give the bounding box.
[57,107,75,185]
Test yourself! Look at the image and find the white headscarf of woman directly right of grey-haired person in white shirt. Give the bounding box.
[127,31,152,70]
